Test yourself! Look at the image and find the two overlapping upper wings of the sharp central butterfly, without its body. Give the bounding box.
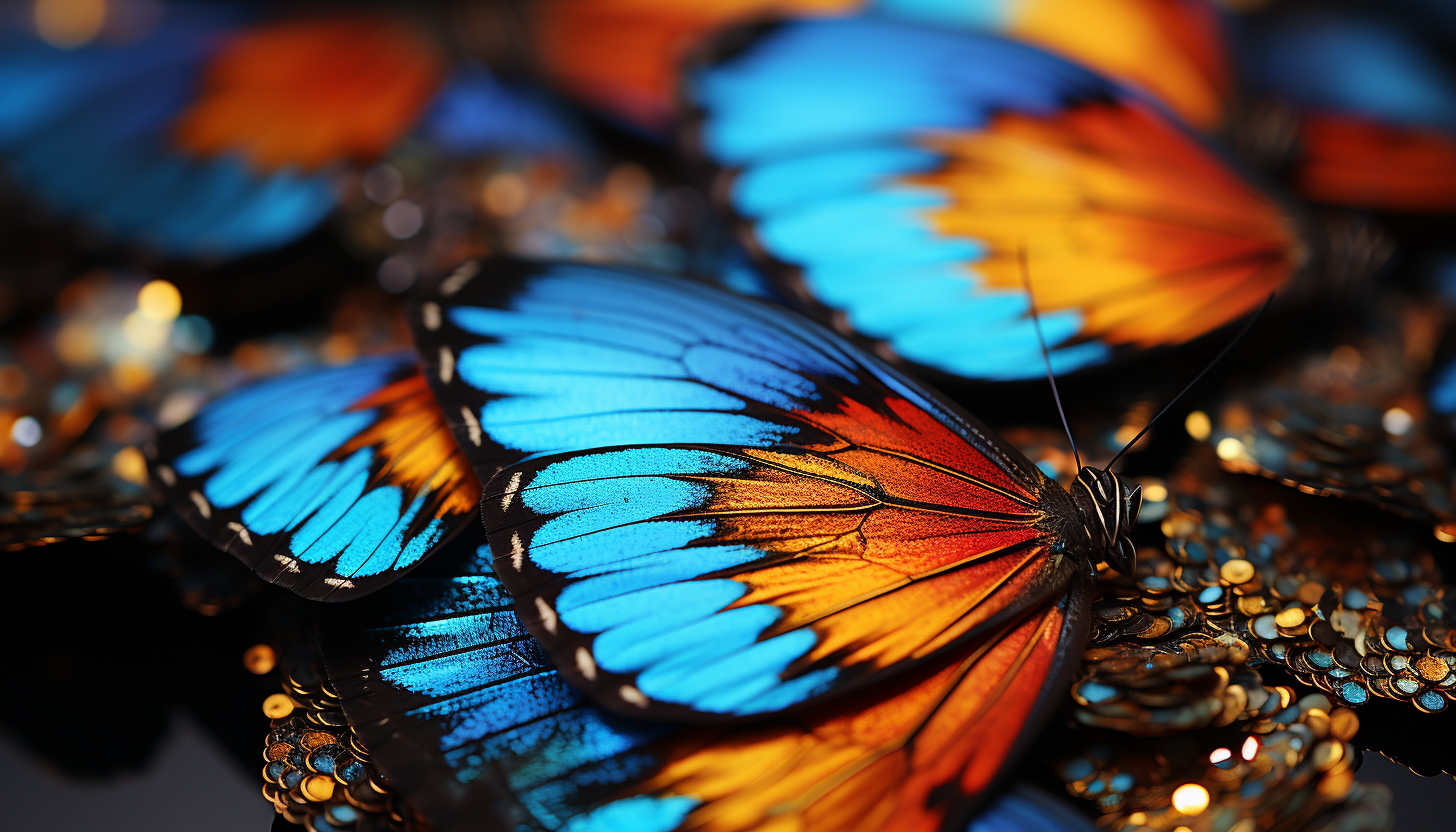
[411,259,1073,718]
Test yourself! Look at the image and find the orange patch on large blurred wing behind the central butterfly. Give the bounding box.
[907,103,1307,347]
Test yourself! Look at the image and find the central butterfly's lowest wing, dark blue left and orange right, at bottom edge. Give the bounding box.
[323,546,1086,832]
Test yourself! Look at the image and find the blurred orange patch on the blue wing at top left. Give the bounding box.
[173,16,444,170]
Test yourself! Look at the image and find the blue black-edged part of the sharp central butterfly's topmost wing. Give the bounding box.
[409,258,1040,484]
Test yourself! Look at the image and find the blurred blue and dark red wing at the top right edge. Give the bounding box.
[1248,9,1456,213]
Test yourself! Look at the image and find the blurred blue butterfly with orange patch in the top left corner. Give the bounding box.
[0,3,573,258]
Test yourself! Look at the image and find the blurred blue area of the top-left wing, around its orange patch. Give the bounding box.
[0,6,333,256]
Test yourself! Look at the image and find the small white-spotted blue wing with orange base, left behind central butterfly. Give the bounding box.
[151,356,480,600]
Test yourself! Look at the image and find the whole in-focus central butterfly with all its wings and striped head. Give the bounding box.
[153,259,1158,829]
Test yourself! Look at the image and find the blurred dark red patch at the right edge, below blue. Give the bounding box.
[1294,115,1456,213]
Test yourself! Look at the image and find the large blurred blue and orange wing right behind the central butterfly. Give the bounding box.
[690,17,1306,379]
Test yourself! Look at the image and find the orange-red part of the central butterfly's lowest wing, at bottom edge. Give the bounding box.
[596,588,1083,832]
